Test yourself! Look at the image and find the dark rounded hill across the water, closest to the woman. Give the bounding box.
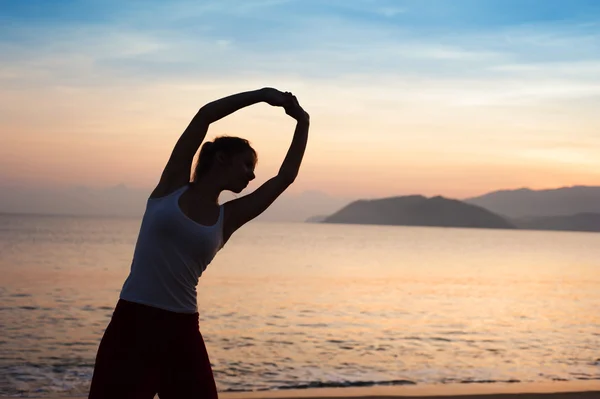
[323,195,515,229]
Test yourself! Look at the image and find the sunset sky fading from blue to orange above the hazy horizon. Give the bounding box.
[0,0,600,219]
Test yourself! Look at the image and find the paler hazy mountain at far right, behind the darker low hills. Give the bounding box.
[464,186,600,218]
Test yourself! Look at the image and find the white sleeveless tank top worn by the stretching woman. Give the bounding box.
[120,185,223,313]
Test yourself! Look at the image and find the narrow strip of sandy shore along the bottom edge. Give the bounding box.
[0,380,600,399]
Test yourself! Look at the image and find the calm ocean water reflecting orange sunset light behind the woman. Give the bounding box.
[0,215,600,397]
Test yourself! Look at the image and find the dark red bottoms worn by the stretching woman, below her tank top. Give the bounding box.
[89,299,218,399]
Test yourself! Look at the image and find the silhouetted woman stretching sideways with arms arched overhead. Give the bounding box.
[89,88,309,399]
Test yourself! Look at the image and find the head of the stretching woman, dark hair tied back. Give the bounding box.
[192,136,258,193]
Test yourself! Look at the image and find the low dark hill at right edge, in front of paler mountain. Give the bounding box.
[512,213,600,232]
